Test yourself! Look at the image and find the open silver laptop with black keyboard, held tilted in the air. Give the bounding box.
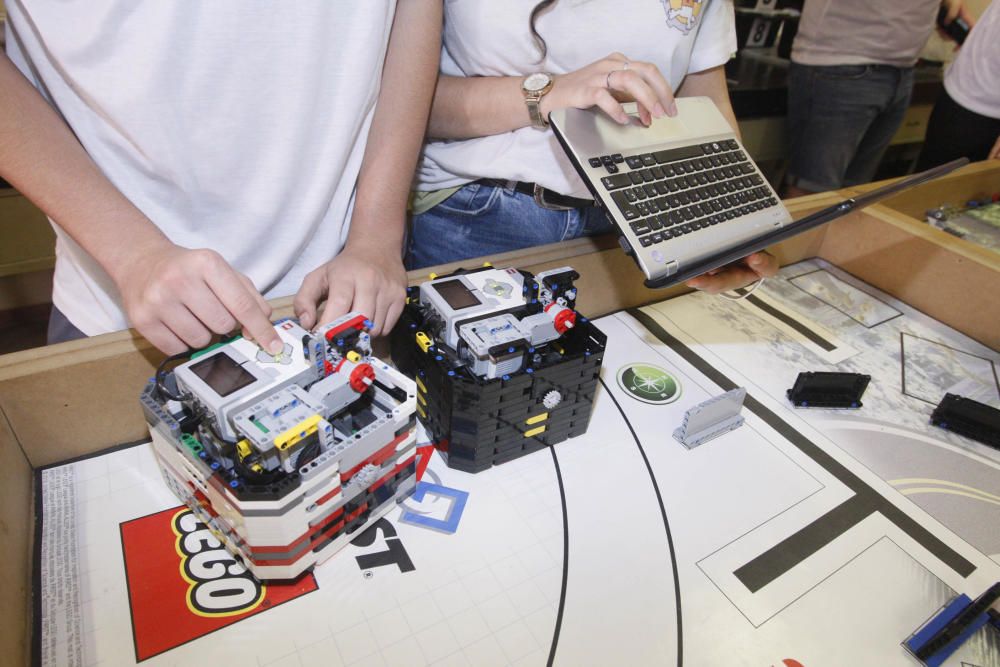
[549,97,968,288]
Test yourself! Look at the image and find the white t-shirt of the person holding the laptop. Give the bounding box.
[417,0,736,197]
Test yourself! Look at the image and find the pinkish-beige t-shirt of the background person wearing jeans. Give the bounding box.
[792,0,941,67]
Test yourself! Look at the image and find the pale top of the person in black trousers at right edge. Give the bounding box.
[944,2,1000,118]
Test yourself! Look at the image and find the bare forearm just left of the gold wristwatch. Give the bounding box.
[427,75,532,139]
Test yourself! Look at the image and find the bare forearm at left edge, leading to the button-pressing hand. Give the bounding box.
[0,54,169,278]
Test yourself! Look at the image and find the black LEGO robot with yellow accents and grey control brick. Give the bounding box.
[391,266,607,473]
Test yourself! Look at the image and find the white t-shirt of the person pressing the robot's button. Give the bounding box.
[6,0,395,335]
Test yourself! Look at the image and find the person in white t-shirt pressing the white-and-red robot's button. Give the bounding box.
[0,0,441,354]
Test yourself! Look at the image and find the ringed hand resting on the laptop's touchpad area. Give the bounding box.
[539,53,677,125]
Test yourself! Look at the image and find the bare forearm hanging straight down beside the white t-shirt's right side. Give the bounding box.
[347,0,441,253]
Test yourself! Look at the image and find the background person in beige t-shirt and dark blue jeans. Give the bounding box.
[785,0,971,197]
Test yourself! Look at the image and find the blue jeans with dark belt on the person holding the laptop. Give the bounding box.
[406,183,613,269]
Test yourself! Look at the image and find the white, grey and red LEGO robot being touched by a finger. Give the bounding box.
[141,313,416,579]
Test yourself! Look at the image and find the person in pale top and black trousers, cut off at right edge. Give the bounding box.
[917,0,1000,170]
